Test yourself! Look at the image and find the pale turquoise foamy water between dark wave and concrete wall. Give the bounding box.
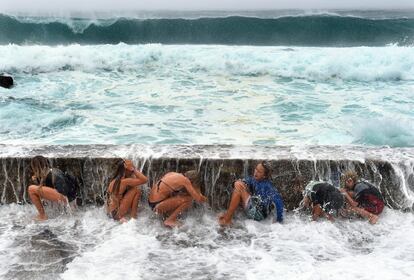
[0,44,414,147]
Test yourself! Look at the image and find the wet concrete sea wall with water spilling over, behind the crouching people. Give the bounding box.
[0,145,414,210]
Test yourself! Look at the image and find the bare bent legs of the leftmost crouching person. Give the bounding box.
[28,185,67,221]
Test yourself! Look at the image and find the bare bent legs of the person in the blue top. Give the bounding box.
[219,181,250,226]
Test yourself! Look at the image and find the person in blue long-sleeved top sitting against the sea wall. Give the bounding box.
[219,161,283,226]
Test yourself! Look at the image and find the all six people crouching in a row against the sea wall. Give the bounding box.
[28,156,384,227]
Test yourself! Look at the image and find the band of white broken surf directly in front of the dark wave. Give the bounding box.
[0,44,414,82]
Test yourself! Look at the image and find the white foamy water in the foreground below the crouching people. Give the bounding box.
[0,205,414,280]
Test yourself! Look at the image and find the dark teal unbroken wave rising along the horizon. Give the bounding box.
[0,14,414,47]
